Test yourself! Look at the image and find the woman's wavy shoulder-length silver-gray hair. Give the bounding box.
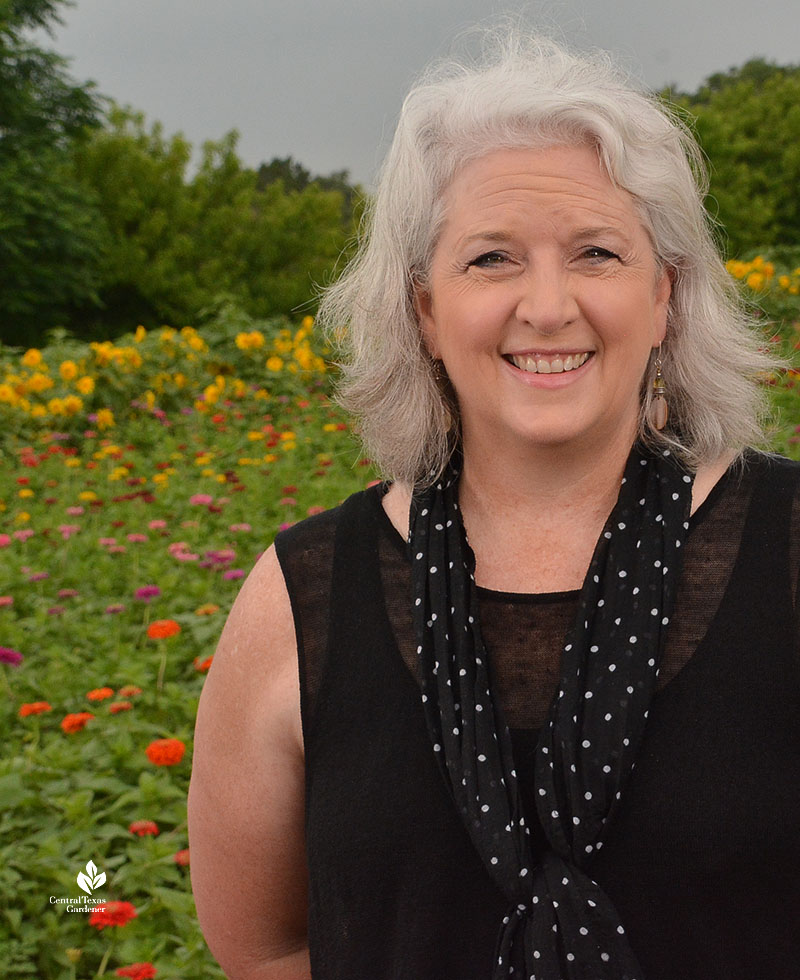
[320,34,776,486]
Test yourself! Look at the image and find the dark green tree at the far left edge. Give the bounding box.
[0,0,102,344]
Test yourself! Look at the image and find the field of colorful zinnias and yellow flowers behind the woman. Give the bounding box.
[0,258,800,980]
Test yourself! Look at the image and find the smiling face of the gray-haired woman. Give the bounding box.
[416,145,670,462]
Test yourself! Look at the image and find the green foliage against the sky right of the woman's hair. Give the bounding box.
[667,59,800,256]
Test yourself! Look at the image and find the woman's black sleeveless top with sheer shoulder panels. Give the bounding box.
[276,453,800,980]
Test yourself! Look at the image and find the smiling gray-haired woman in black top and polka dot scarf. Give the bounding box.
[190,30,800,980]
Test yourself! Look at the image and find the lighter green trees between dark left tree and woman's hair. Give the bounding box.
[71,108,360,336]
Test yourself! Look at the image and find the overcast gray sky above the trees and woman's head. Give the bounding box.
[49,0,800,185]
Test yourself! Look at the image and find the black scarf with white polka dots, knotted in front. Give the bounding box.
[409,446,692,980]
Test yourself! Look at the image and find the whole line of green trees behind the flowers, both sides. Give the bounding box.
[0,0,800,345]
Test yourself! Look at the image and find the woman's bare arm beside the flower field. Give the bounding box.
[189,548,311,980]
